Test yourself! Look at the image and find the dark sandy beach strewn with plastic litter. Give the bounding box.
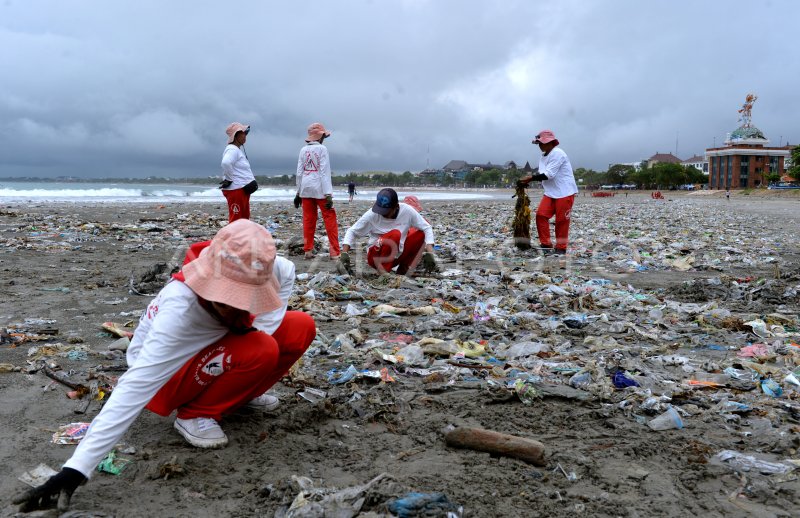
[0,191,800,517]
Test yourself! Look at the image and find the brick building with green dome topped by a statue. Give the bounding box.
[706,94,793,189]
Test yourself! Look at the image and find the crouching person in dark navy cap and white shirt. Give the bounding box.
[340,188,436,275]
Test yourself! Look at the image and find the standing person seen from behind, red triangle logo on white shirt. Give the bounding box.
[294,122,339,259]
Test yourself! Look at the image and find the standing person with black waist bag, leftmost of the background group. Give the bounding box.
[220,122,258,222]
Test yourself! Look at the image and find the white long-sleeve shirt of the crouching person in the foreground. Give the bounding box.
[64,257,295,478]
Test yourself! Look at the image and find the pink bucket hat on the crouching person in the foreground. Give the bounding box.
[183,219,283,315]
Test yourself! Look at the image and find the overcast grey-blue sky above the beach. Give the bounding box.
[0,0,800,177]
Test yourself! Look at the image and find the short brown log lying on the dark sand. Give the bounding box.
[444,428,545,466]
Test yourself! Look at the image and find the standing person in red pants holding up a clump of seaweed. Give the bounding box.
[519,130,578,254]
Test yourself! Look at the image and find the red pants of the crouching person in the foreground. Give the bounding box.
[147,311,317,420]
